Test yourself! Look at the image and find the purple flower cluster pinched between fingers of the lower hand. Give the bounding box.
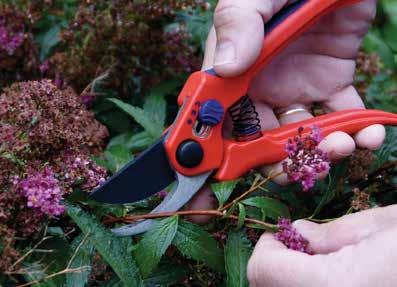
[274,218,309,254]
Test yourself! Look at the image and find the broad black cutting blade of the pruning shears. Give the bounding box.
[91,138,176,204]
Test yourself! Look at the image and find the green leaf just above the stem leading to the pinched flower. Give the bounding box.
[242,196,290,219]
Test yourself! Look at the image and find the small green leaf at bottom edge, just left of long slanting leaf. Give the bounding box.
[65,234,94,287]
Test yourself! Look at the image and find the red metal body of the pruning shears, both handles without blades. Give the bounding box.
[165,0,397,180]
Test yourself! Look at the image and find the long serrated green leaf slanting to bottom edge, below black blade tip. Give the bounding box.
[66,203,143,287]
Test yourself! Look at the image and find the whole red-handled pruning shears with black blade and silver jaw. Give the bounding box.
[91,0,397,236]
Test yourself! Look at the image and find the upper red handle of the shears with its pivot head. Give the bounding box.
[165,0,366,176]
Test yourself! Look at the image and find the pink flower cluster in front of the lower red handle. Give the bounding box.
[283,126,330,191]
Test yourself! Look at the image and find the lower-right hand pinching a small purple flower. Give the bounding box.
[247,205,397,287]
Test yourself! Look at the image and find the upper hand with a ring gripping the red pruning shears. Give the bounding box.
[203,0,385,184]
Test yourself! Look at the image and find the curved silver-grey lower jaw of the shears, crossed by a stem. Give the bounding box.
[112,171,212,236]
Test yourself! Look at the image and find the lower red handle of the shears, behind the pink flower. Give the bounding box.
[215,110,397,180]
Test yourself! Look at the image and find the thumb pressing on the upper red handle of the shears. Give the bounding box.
[210,0,287,77]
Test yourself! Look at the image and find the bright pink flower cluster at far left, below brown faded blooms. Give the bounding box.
[14,166,65,217]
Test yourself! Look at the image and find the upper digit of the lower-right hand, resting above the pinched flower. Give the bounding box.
[293,205,397,254]
